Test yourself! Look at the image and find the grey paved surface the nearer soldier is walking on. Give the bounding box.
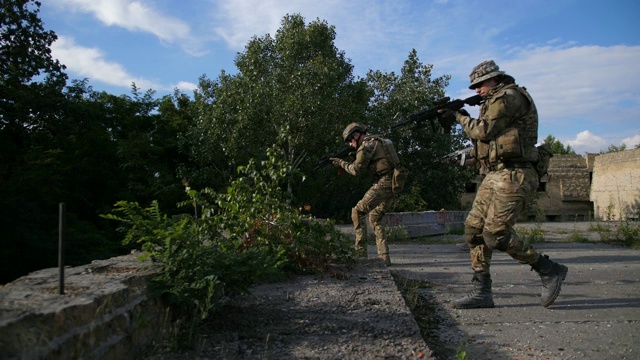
[376,223,640,359]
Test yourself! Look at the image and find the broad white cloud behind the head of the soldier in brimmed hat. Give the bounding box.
[501,45,640,121]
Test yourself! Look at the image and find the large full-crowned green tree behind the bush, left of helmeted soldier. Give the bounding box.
[191,15,370,219]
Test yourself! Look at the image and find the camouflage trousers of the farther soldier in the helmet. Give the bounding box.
[351,174,394,255]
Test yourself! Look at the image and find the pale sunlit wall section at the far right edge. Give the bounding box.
[590,149,640,220]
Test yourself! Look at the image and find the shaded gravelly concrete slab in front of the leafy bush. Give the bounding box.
[146,259,433,360]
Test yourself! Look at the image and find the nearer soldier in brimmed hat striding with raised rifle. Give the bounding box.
[440,60,568,309]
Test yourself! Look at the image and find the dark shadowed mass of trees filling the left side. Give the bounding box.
[0,0,195,283]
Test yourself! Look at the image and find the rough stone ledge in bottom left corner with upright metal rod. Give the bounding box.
[0,255,170,360]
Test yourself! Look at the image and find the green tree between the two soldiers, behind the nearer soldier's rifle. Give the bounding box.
[367,49,472,211]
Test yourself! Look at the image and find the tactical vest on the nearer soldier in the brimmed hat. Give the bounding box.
[473,84,538,165]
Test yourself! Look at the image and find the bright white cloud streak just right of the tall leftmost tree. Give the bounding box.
[51,36,158,89]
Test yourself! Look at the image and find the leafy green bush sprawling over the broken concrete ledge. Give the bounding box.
[104,142,353,319]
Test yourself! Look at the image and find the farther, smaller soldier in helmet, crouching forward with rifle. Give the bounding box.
[331,123,401,265]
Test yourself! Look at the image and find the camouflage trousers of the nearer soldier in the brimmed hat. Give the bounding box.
[464,166,540,272]
